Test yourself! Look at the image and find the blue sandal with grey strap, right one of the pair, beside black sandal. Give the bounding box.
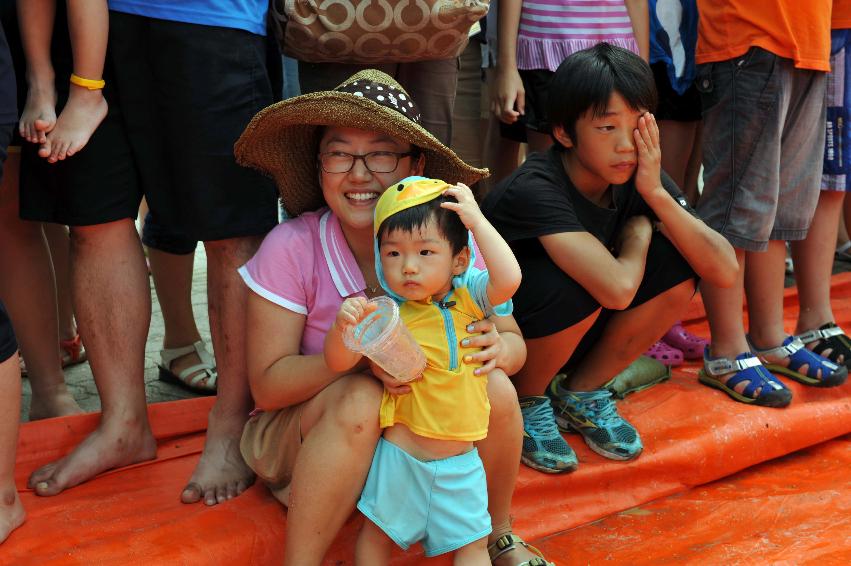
[751,336,848,387]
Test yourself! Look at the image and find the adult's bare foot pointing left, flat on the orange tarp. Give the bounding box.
[27,418,157,495]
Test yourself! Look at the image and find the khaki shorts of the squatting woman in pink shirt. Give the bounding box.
[239,403,304,505]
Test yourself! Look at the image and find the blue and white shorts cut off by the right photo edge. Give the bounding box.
[821,29,851,191]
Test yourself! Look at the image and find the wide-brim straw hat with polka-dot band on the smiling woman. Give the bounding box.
[234,69,488,216]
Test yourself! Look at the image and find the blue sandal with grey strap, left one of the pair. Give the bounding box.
[697,348,792,408]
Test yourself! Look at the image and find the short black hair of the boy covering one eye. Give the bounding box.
[547,43,658,149]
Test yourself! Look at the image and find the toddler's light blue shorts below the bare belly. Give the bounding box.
[358,438,491,556]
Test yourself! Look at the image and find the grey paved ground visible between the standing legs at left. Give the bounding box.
[21,246,212,421]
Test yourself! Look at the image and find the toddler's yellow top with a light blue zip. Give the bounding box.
[379,287,490,441]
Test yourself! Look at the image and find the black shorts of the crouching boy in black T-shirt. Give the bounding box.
[513,233,697,364]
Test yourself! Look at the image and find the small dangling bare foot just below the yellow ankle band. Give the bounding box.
[38,85,107,163]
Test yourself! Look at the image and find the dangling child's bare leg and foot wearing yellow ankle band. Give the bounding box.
[38,0,109,163]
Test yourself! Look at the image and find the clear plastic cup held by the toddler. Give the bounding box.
[343,297,426,381]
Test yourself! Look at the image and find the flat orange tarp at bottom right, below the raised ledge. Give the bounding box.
[537,436,851,566]
